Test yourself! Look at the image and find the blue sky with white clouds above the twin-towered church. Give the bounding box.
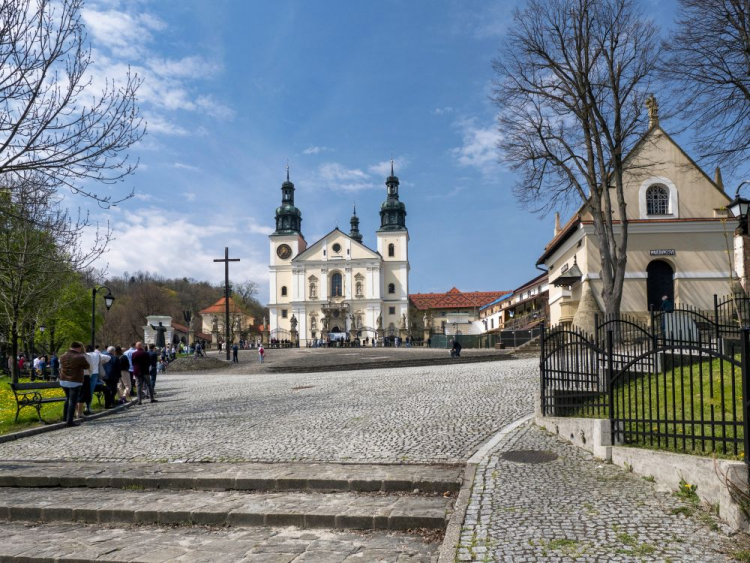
[83,0,692,300]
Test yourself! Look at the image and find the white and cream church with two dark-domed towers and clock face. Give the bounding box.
[268,161,409,342]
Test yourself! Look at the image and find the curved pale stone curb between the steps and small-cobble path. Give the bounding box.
[438,414,534,563]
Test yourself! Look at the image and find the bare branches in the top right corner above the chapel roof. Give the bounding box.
[661,0,750,169]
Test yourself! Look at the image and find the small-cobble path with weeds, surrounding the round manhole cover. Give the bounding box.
[458,425,738,563]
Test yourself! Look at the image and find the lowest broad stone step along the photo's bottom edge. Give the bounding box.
[0,523,440,563]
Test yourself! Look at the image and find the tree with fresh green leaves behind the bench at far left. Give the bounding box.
[0,179,110,381]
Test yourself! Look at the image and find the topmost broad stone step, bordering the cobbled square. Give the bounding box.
[0,461,463,493]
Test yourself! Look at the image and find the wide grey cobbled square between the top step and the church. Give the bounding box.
[0,359,538,463]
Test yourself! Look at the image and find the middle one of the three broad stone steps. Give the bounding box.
[0,487,453,530]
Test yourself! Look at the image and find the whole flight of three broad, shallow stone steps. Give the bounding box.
[0,462,462,563]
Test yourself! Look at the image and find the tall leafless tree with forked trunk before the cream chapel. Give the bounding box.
[493,0,658,314]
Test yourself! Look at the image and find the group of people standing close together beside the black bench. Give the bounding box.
[60,342,164,426]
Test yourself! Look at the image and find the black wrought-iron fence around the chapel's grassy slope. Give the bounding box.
[540,297,750,457]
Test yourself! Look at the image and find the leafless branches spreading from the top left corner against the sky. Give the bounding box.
[0,0,145,206]
